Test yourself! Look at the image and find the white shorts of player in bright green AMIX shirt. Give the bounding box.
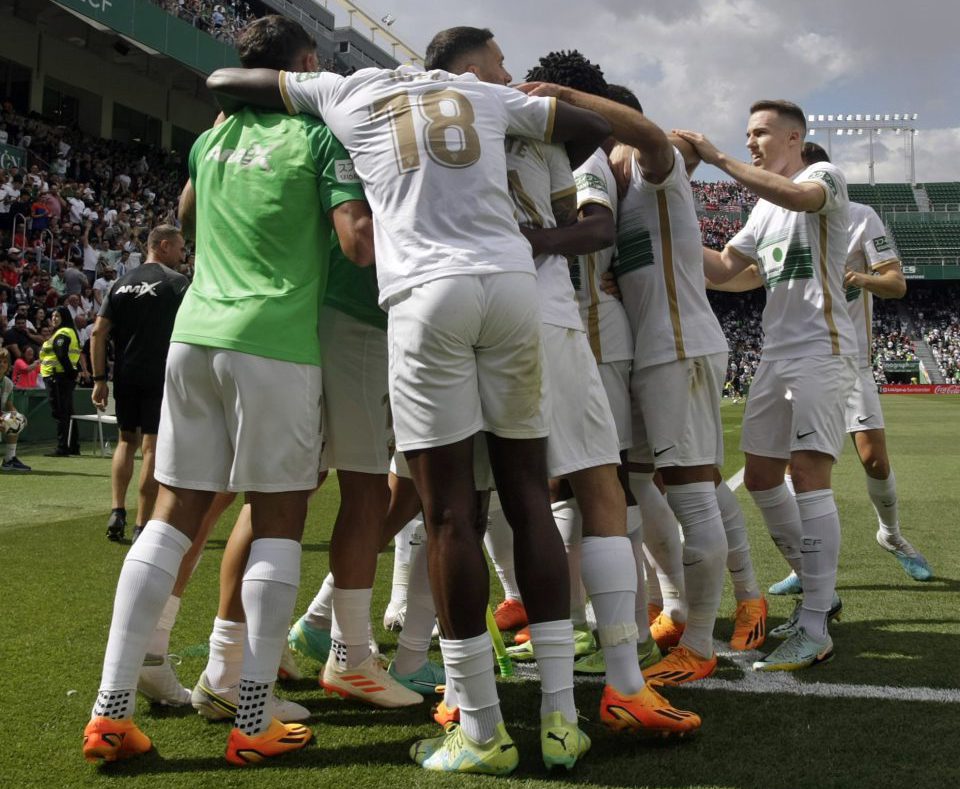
[154,342,323,493]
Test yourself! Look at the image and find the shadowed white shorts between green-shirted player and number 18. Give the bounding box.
[320,307,393,474]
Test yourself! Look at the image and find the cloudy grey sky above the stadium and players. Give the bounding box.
[328,0,960,182]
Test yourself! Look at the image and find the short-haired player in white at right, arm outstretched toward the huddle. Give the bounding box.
[677,100,857,671]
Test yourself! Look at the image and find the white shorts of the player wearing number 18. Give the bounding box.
[387,272,547,451]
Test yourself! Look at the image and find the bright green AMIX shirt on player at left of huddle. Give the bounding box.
[171,108,363,365]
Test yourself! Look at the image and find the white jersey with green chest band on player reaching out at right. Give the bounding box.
[727,162,857,361]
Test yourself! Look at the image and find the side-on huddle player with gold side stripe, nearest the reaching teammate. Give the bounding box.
[520,81,762,684]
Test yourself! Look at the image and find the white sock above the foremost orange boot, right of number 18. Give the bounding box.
[583,537,644,695]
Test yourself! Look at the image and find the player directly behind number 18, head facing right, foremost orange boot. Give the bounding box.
[427,28,700,744]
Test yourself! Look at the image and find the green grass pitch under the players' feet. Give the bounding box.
[0,396,960,789]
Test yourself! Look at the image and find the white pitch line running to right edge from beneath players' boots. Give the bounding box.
[513,641,960,704]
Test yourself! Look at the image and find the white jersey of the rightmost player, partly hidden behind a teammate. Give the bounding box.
[846,202,900,367]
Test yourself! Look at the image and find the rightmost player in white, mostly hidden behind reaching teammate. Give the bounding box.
[770,142,933,594]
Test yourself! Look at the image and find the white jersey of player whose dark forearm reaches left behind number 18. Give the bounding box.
[571,148,633,363]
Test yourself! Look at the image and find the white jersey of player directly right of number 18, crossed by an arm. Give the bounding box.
[507,137,583,329]
